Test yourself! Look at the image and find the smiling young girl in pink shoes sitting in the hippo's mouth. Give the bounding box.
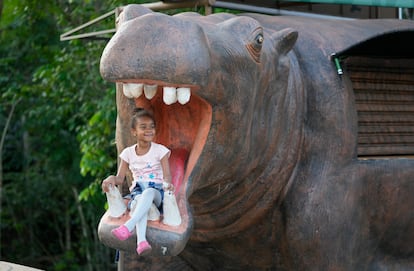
[102,108,174,255]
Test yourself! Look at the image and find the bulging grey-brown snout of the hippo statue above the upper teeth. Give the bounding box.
[100,9,211,86]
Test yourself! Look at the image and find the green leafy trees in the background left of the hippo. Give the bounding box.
[0,0,205,271]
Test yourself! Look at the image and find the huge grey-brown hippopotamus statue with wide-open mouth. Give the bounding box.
[98,5,414,271]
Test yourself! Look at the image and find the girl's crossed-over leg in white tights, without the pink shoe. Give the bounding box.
[124,188,161,233]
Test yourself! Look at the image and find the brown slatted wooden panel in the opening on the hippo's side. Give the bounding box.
[346,57,414,157]
